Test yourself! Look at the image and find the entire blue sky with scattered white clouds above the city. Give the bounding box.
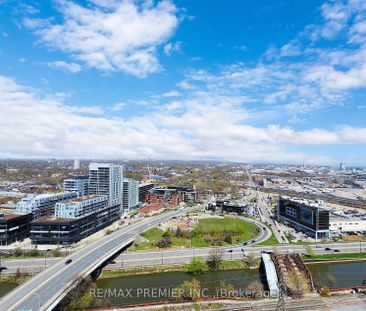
[0,0,366,166]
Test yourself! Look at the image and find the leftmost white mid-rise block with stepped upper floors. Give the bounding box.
[16,192,77,218]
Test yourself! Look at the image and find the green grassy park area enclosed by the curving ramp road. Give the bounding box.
[132,217,259,250]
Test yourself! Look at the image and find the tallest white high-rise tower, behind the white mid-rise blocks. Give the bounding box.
[89,163,123,214]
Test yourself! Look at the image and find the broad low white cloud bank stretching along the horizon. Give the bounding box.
[0,76,366,163]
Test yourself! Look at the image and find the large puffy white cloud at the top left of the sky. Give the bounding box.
[24,0,179,77]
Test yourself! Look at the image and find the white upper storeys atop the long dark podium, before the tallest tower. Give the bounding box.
[55,195,108,218]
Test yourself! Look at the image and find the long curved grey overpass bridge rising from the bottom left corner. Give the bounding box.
[0,210,187,311]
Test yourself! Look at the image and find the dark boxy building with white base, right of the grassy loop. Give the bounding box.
[277,197,329,240]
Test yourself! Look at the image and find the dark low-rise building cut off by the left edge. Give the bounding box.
[0,214,32,246]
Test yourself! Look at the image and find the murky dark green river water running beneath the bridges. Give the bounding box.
[0,261,366,305]
